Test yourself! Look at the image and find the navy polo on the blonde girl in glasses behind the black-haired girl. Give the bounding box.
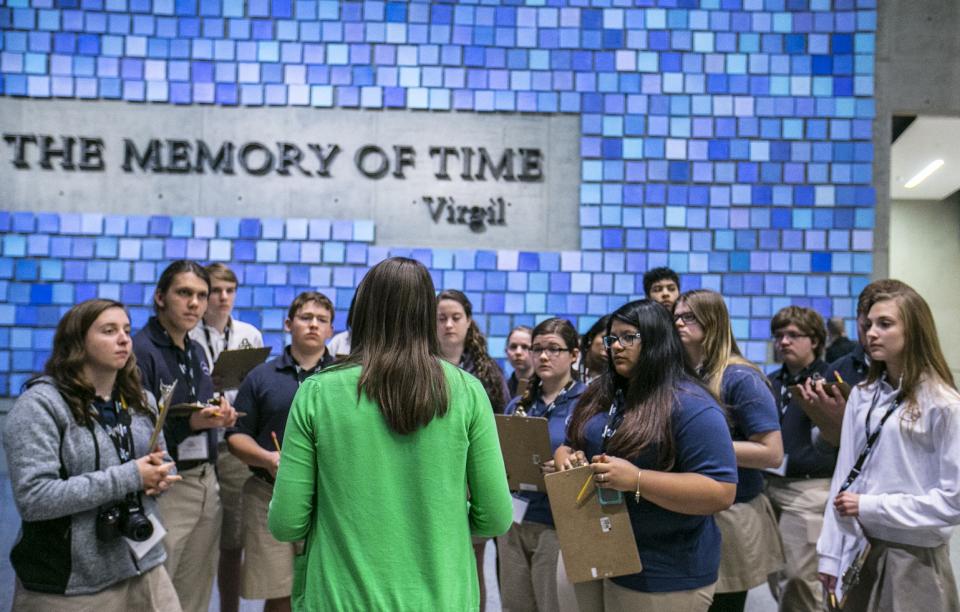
[720,365,780,503]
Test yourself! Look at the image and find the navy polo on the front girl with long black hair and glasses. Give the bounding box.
[583,381,737,593]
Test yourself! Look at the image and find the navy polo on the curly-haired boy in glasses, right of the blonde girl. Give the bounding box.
[770,359,837,478]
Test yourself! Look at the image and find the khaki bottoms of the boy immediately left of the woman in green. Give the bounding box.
[240,476,294,599]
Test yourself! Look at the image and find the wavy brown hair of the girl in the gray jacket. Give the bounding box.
[34,298,150,425]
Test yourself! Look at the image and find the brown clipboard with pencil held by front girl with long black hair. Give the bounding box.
[544,466,643,583]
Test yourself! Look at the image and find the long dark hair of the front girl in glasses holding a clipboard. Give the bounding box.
[567,299,692,470]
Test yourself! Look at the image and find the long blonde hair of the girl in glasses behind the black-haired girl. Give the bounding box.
[677,289,767,398]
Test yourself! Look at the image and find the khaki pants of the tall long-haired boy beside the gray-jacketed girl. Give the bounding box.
[159,463,222,612]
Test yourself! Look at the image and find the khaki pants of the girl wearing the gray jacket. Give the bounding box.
[11,565,180,612]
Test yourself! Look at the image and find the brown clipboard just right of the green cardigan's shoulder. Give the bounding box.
[494,414,553,493]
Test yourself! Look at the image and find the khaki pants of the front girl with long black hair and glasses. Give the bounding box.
[557,554,716,612]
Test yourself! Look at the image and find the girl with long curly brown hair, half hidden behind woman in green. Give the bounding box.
[437,289,510,610]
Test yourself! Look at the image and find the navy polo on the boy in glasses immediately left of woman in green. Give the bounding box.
[226,346,334,482]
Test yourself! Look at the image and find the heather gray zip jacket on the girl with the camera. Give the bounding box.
[3,377,166,595]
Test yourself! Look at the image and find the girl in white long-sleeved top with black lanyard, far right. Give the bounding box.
[817,286,960,612]
